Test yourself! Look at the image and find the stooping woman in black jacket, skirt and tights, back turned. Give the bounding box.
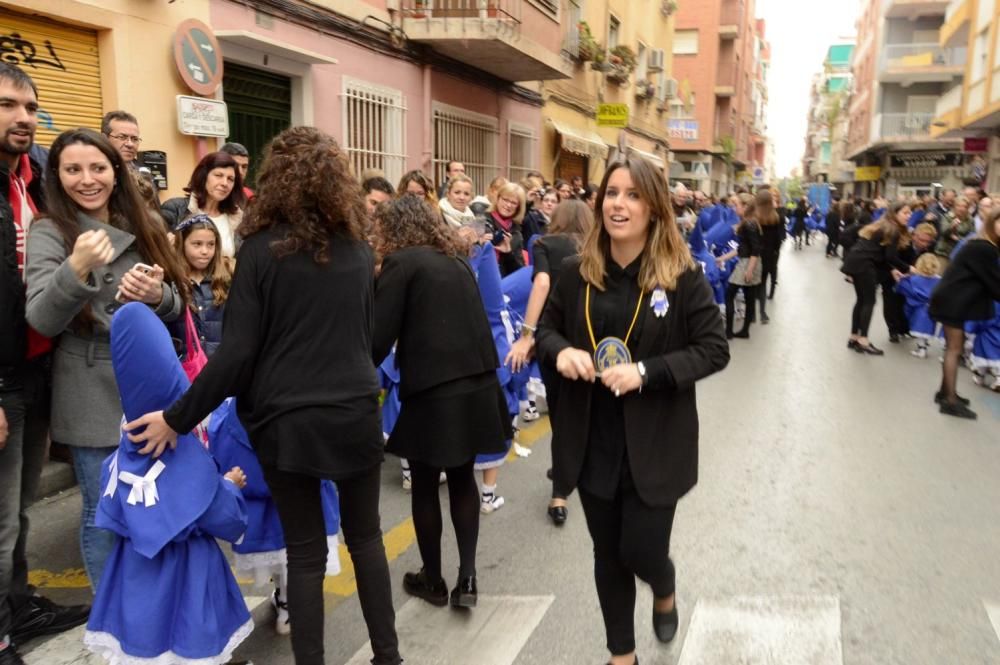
[372,196,513,607]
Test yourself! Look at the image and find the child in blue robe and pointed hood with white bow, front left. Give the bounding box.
[84,303,253,665]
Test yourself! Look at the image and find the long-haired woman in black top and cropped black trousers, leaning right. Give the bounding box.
[840,202,910,356]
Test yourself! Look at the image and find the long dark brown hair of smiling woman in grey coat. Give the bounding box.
[45,128,189,332]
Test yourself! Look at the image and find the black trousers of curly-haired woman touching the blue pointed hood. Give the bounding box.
[264,466,403,665]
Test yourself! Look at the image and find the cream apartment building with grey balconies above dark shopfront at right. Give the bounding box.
[848,0,967,197]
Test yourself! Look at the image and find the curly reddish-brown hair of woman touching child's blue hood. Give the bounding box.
[237,127,367,263]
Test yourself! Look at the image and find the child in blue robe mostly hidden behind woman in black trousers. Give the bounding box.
[208,398,340,635]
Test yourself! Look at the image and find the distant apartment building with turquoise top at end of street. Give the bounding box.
[802,38,854,194]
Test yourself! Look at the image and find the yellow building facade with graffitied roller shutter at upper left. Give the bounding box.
[0,0,214,195]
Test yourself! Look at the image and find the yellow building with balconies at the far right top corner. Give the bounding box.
[931,0,1000,192]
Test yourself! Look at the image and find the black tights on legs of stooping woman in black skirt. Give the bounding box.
[410,459,479,580]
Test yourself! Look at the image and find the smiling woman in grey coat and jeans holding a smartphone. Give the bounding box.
[25,129,186,589]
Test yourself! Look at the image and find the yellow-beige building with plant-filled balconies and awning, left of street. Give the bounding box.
[540,0,677,187]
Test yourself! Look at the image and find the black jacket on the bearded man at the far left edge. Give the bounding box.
[0,159,45,371]
